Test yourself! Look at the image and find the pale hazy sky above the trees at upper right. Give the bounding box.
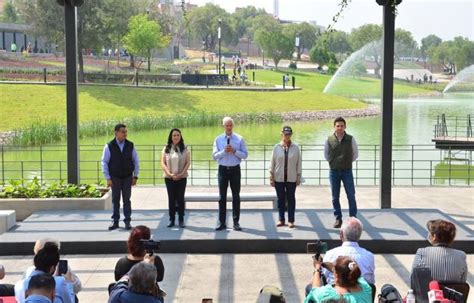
[186,0,474,43]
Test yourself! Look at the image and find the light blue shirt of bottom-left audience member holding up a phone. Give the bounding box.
[15,270,76,303]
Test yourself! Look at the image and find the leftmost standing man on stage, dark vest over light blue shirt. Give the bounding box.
[102,124,139,230]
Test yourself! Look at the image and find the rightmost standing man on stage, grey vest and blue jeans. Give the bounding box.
[324,117,359,228]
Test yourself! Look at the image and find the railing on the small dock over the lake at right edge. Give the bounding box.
[434,114,473,140]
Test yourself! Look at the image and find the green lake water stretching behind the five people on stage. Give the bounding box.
[0,94,474,185]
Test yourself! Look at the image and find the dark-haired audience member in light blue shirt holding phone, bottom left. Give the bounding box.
[15,242,76,303]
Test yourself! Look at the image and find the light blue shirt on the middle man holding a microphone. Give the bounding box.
[212,133,248,166]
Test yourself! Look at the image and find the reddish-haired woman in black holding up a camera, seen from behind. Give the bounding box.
[114,225,165,282]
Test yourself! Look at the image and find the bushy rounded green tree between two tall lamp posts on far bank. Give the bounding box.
[255,21,294,68]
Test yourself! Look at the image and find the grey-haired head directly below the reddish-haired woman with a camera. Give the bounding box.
[128,261,157,293]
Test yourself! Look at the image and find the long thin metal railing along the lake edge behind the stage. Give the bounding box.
[0,144,474,186]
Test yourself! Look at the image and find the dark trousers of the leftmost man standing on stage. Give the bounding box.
[112,176,132,223]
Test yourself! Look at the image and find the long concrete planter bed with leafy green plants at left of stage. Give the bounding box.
[0,178,112,221]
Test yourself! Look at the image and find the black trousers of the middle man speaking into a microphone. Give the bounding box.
[218,165,240,224]
